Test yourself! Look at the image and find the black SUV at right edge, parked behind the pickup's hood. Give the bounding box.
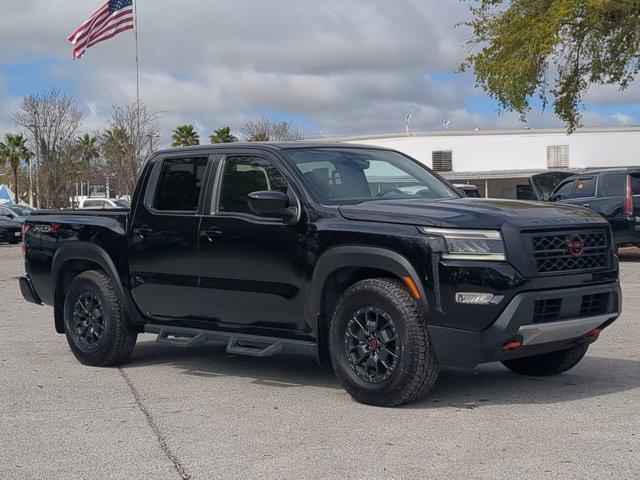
[548,168,640,247]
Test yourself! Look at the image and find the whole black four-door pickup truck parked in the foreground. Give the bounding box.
[20,143,621,406]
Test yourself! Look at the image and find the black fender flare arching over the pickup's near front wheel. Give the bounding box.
[305,245,427,342]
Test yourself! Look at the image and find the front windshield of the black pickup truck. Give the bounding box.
[286,148,460,204]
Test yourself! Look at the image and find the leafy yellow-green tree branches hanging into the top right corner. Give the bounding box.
[460,0,640,131]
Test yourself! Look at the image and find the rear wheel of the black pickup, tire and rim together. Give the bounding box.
[64,271,138,367]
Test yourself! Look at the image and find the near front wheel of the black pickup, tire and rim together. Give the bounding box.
[329,278,438,407]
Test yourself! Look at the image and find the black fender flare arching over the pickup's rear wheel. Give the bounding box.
[51,242,144,333]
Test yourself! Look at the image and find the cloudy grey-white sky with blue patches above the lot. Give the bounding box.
[0,0,640,143]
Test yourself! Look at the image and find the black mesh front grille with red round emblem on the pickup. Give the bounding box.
[531,230,610,274]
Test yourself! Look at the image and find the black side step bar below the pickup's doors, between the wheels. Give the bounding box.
[144,324,316,357]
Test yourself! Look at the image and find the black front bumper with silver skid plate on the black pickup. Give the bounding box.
[427,282,622,367]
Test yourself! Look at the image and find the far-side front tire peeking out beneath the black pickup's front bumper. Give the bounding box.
[502,345,589,377]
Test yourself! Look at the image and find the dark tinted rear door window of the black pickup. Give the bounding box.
[153,157,208,212]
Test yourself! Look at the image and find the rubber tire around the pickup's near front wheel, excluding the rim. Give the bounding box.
[329,278,439,407]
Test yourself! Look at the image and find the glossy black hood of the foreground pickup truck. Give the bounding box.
[340,198,607,229]
